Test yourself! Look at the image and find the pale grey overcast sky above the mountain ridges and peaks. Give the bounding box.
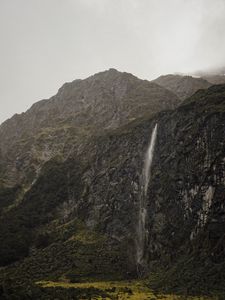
[0,0,225,123]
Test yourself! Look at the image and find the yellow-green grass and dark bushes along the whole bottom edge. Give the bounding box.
[1,281,219,300]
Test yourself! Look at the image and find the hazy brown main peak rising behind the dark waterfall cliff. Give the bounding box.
[0,69,179,186]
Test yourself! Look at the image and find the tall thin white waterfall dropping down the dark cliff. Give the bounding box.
[137,123,158,268]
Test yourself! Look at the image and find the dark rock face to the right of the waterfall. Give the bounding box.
[144,86,225,262]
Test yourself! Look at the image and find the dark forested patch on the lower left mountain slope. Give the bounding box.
[0,160,84,266]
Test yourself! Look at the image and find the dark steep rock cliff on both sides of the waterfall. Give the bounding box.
[66,86,225,265]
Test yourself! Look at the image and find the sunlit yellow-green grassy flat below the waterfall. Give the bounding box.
[37,281,217,300]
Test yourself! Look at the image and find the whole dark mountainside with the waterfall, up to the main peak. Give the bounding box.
[0,70,225,299]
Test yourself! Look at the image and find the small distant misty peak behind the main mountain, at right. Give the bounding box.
[153,74,212,100]
